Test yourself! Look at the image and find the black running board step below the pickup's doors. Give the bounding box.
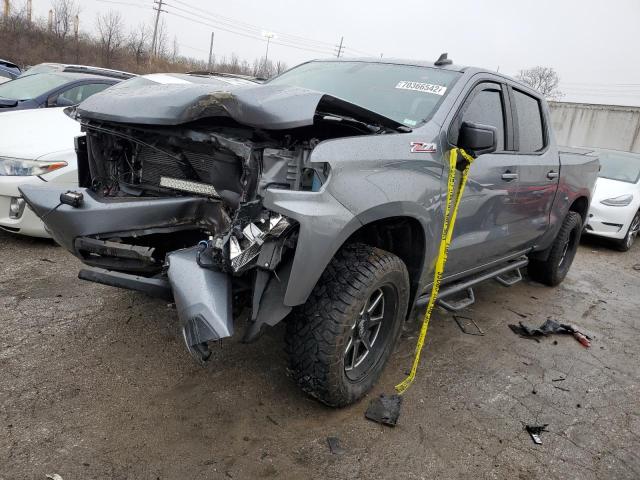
[416,257,529,312]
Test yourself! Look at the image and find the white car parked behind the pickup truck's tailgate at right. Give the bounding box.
[585,149,640,252]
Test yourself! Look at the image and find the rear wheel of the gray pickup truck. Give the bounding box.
[527,212,582,287]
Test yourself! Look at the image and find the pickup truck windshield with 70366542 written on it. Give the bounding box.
[268,61,461,127]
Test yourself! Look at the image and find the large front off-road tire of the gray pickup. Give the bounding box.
[286,244,409,407]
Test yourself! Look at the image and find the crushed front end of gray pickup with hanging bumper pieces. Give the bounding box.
[17,81,398,362]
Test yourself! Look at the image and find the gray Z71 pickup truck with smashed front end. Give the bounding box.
[21,58,599,406]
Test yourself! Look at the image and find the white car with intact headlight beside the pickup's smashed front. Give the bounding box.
[0,108,81,238]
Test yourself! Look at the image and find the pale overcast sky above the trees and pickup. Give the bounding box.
[28,0,640,105]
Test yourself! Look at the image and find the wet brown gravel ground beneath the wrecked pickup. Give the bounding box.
[0,232,640,480]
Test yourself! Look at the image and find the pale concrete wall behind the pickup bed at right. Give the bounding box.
[549,102,640,153]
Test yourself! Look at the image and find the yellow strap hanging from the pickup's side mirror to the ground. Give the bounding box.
[396,148,473,395]
